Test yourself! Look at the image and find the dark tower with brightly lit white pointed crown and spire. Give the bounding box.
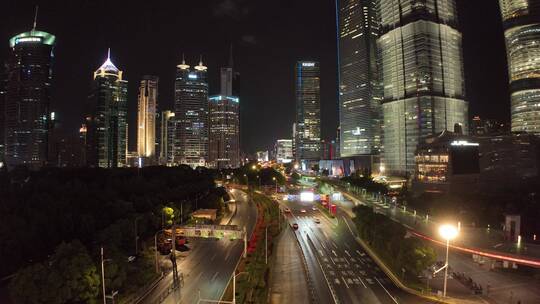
[86,52,128,168]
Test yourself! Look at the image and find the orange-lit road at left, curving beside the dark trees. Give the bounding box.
[141,190,257,304]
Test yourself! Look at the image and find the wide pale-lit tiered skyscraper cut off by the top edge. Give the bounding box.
[376,0,468,175]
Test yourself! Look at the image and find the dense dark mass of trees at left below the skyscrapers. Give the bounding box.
[0,166,223,303]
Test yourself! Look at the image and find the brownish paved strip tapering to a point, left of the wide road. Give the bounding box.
[269,229,309,304]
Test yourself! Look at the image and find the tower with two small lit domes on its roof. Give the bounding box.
[174,56,208,167]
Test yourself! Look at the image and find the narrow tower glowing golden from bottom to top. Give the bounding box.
[137,75,159,164]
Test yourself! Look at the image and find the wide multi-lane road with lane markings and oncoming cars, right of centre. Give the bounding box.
[280,192,431,304]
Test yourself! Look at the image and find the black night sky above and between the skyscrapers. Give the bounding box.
[0,0,510,152]
